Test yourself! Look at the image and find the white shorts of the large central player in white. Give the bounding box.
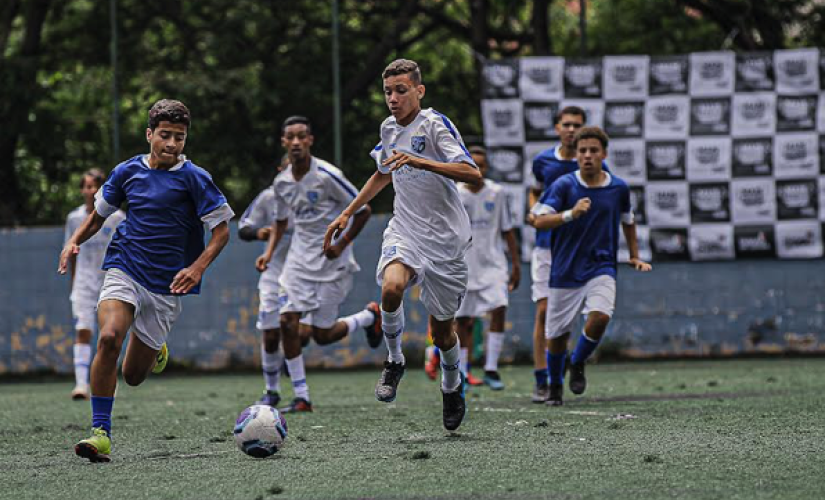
[375,228,469,321]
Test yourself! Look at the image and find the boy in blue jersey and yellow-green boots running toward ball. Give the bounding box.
[58,99,234,462]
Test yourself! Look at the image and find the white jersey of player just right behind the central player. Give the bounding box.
[458,180,513,291]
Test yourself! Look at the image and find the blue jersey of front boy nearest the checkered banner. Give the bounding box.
[532,172,633,288]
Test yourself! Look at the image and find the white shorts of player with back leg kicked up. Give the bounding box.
[279,273,352,328]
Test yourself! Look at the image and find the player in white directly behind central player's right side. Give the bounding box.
[456,146,521,391]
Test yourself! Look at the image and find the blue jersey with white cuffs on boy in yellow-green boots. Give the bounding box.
[95,155,235,295]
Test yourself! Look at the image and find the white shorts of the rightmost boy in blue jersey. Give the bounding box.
[544,275,616,339]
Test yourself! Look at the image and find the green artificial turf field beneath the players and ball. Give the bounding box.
[0,359,825,500]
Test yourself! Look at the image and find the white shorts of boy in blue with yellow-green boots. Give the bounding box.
[98,269,183,351]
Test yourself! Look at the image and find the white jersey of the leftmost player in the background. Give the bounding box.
[63,205,126,302]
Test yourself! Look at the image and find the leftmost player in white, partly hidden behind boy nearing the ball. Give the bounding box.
[63,168,126,400]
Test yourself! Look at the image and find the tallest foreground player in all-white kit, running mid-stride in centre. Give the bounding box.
[324,59,482,431]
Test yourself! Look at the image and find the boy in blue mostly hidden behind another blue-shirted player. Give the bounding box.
[529,106,587,403]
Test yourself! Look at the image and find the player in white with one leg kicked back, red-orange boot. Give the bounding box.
[255,116,381,413]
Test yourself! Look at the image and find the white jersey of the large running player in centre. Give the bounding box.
[371,108,475,261]
